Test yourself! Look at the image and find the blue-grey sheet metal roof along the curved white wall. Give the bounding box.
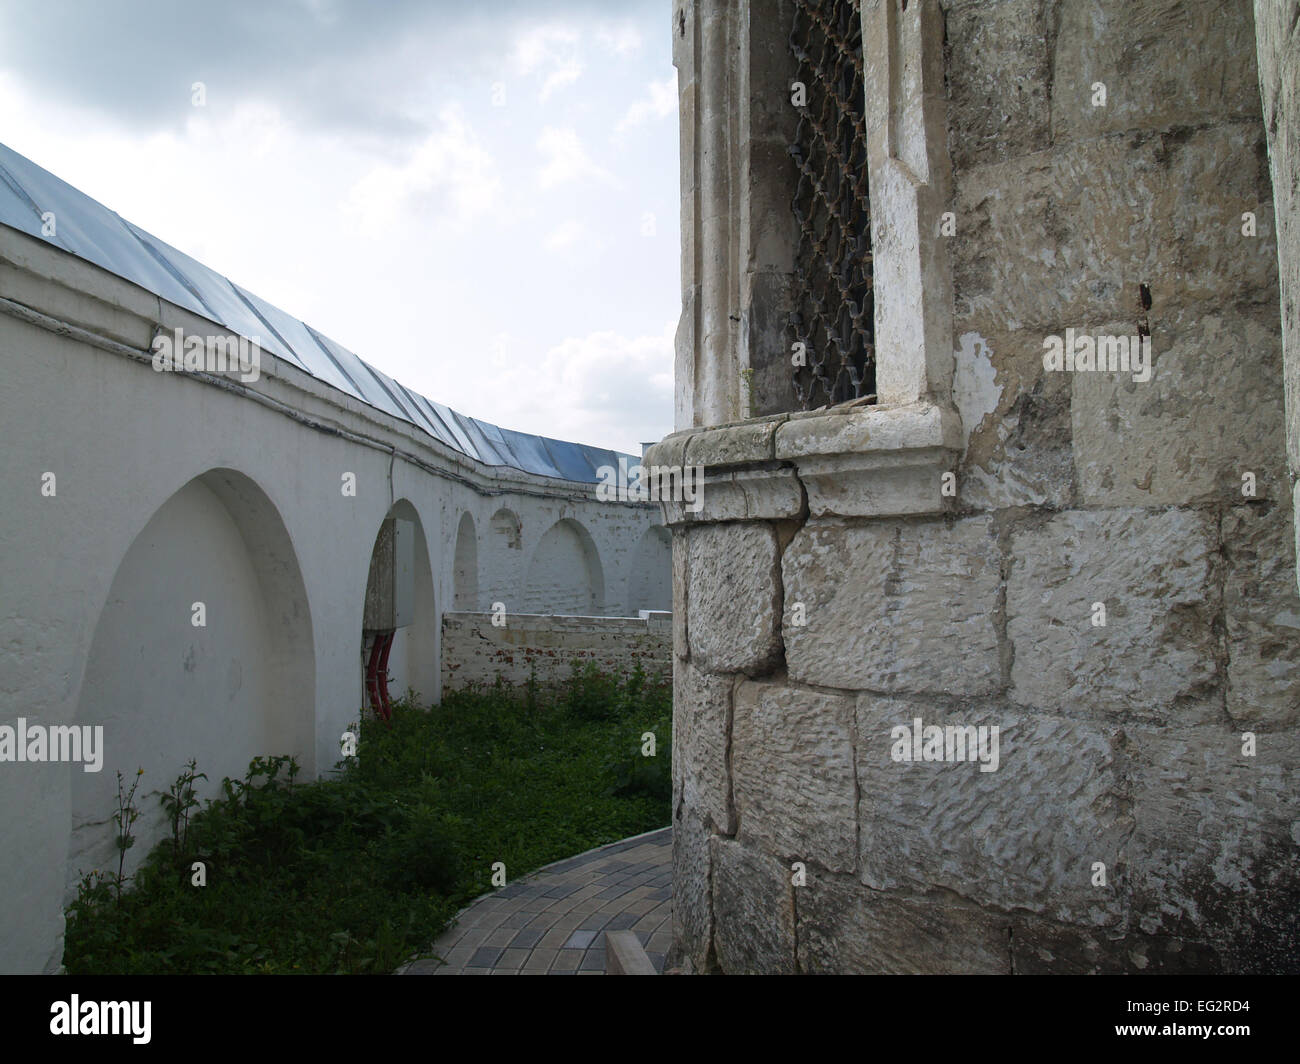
[0,144,640,484]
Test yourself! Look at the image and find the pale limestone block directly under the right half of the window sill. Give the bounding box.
[781,518,1001,695]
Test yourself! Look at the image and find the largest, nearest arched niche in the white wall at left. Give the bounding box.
[68,468,316,890]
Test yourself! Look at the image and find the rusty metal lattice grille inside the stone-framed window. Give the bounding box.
[790,0,876,410]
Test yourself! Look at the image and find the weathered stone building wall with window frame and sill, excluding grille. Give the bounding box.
[646,0,1300,973]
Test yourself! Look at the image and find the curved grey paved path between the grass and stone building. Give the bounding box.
[398,827,672,976]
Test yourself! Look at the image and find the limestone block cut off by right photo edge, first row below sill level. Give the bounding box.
[1222,501,1300,727]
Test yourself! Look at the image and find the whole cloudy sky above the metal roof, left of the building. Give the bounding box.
[0,0,680,454]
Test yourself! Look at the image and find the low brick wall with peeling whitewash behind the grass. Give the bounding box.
[442,611,672,691]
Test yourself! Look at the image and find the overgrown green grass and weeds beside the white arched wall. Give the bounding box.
[64,670,671,974]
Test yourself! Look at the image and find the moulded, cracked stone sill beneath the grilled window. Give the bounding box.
[642,403,962,525]
